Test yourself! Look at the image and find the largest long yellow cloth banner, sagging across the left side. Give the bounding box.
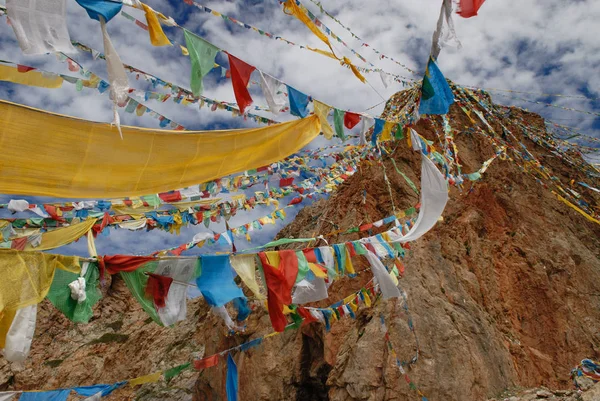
[0,101,321,198]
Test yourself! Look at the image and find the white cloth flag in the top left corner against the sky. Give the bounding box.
[6,0,75,54]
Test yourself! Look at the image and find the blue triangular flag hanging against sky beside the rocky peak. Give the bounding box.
[419,57,454,114]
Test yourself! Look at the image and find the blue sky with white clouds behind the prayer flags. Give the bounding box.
[0,0,600,255]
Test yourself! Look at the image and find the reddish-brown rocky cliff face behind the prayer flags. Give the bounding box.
[0,91,600,401]
